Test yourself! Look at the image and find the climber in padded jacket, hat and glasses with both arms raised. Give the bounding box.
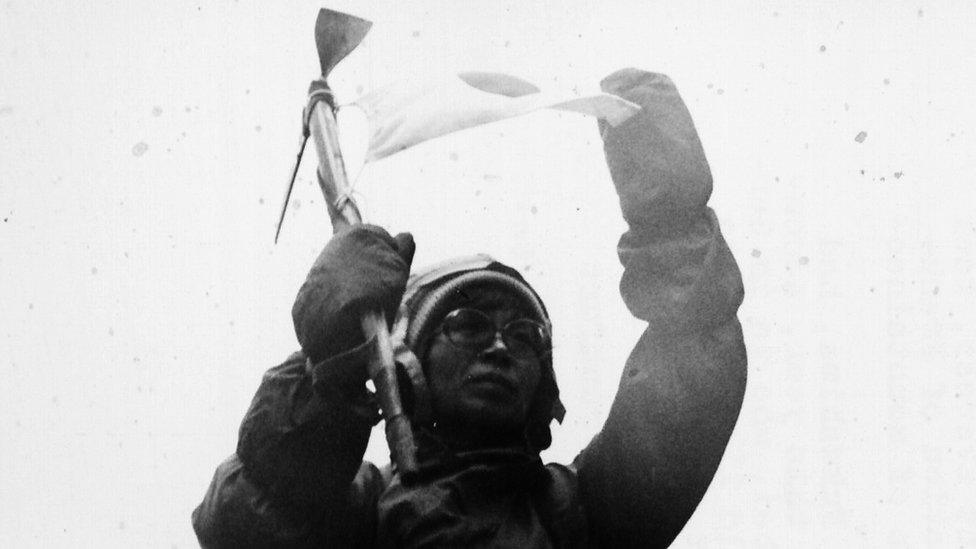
[193,69,746,548]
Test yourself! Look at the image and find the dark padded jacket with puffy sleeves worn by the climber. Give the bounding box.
[193,70,746,548]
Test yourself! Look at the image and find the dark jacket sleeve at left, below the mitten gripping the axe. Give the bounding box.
[193,346,382,549]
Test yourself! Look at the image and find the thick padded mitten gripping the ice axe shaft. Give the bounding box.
[291,225,415,363]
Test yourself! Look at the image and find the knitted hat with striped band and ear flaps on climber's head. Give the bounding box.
[393,254,566,451]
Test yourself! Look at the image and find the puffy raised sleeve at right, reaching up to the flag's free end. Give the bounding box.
[575,69,746,547]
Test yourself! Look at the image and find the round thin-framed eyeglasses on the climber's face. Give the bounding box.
[441,309,549,358]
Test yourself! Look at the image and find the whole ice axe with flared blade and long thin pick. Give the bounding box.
[275,9,417,479]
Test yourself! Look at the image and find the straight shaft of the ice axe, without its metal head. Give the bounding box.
[309,101,417,478]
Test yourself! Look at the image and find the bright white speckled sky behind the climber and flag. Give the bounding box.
[0,0,976,548]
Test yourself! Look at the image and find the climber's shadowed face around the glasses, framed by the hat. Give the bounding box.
[425,289,541,430]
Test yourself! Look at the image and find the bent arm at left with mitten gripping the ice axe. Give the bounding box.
[193,226,413,549]
